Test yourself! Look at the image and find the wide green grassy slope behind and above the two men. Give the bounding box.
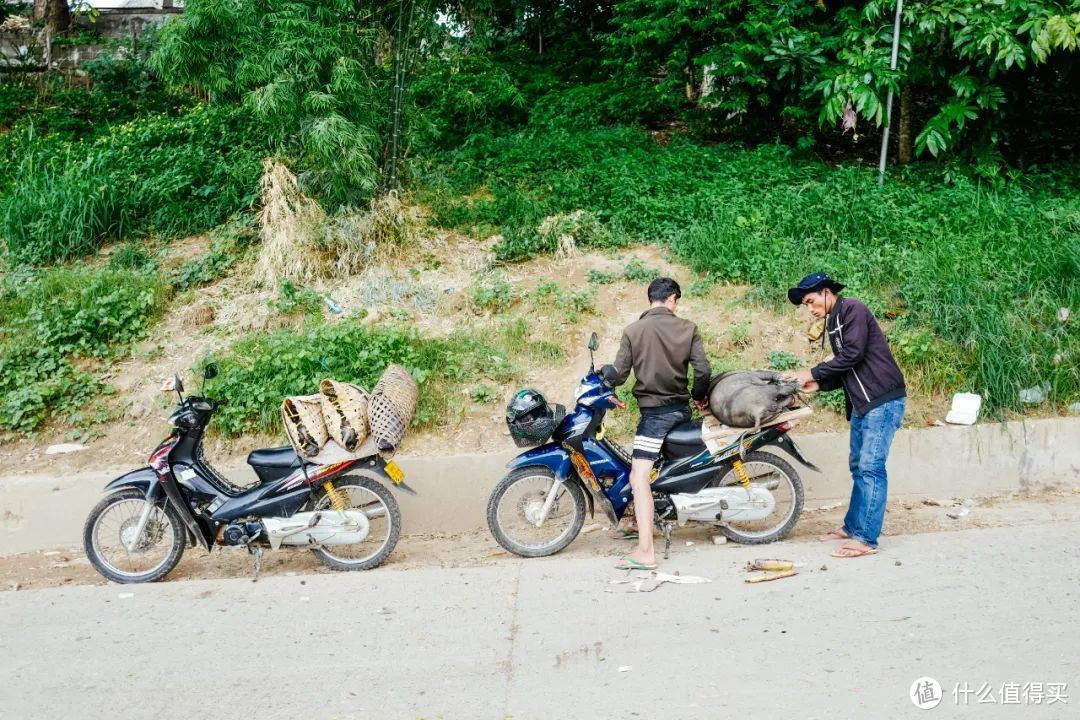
[414,127,1080,410]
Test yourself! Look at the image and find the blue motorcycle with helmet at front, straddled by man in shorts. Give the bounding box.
[487,332,818,557]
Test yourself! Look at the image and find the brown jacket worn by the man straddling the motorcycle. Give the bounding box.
[607,308,712,407]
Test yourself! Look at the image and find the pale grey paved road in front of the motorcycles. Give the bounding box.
[0,521,1080,720]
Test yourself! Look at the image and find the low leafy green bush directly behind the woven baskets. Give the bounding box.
[210,318,513,435]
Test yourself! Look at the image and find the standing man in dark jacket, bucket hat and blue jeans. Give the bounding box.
[787,272,907,557]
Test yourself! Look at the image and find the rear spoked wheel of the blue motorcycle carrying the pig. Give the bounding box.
[714,450,802,545]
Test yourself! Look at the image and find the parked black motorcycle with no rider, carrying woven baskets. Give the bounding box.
[83,364,413,583]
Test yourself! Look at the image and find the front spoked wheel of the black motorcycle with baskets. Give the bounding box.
[82,488,185,583]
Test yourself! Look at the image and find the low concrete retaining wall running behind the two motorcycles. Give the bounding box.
[0,418,1080,554]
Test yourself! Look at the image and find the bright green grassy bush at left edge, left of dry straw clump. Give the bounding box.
[0,107,264,264]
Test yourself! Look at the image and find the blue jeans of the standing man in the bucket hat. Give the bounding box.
[843,397,907,547]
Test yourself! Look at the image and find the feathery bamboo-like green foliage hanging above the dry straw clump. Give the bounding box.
[152,0,412,207]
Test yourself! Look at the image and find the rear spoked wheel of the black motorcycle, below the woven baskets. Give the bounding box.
[311,475,402,570]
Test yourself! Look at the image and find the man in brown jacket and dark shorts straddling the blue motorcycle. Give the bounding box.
[603,277,712,570]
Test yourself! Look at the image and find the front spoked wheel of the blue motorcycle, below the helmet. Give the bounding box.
[487,467,585,557]
